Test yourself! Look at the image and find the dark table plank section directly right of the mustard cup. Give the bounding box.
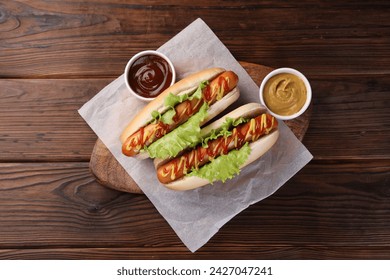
[303,75,390,159]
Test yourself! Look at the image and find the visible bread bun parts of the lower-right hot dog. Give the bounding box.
[154,103,279,191]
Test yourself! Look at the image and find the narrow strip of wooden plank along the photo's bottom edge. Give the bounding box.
[0,244,390,260]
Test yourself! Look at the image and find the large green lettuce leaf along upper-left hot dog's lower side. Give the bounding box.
[144,103,209,159]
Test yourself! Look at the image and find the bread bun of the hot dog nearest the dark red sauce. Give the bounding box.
[120,68,240,159]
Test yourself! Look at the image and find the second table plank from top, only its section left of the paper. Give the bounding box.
[0,79,106,162]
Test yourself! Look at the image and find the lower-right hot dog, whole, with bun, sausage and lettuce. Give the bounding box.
[155,103,279,190]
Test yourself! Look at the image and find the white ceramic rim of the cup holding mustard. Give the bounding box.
[259,68,312,120]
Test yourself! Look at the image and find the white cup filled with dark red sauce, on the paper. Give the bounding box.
[124,50,176,101]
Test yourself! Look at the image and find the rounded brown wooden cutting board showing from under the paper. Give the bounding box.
[89,62,312,194]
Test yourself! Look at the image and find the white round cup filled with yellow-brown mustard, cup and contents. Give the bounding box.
[259,68,312,120]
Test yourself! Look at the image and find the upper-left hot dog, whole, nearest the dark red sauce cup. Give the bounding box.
[121,68,239,158]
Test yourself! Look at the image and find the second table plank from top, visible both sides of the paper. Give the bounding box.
[0,75,390,162]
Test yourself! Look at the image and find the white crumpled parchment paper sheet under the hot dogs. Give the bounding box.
[79,19,312,252]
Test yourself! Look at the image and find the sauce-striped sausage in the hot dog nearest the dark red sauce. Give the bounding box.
[122,71,238,156]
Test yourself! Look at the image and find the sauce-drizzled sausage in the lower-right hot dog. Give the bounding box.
[157,114,278,184]
